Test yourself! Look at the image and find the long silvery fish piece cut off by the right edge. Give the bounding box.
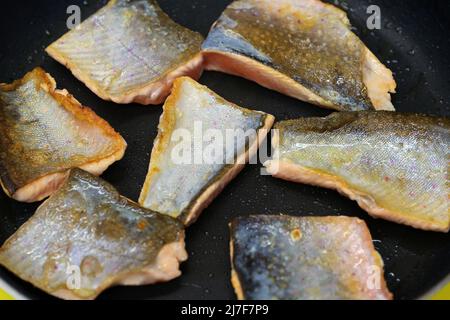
[265,111,450,232]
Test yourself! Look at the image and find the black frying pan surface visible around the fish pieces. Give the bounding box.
[0,0,450,299]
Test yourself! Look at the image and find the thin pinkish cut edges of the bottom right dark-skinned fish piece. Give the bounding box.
[228,216,394,300]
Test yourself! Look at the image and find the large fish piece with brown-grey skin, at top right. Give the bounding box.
[202,0,396,111]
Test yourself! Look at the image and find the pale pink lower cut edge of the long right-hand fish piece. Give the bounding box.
[264,127,450,232]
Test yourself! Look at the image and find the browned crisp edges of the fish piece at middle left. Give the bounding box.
[0,67,127,202]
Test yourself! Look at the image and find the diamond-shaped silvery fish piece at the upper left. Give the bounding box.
[46,0,203,105]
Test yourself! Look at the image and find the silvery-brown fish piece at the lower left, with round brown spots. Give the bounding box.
[0,169,187,299]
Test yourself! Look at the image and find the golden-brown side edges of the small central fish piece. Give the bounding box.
[139,78,275,226]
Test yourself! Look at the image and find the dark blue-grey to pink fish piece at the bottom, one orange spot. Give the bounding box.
[230,215,392,300]
